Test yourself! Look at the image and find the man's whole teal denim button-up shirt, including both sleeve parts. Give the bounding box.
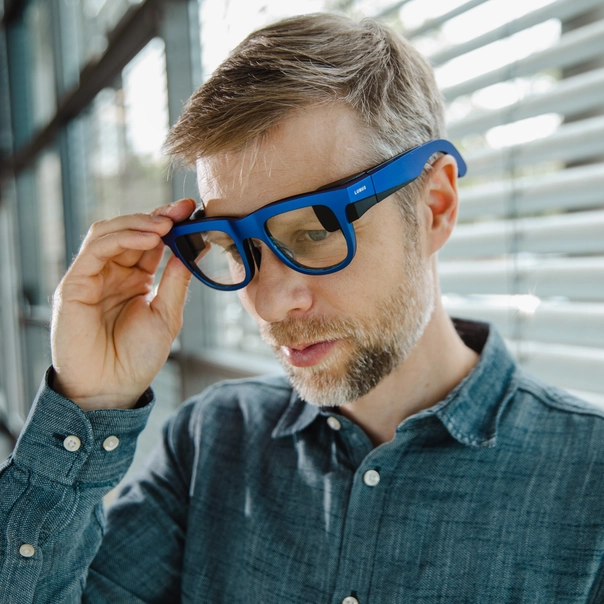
[0,321,604,604]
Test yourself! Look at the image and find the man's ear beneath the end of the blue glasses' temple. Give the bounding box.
[423,155,459,256]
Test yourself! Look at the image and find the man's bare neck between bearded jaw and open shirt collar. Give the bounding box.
[340,300,478,447]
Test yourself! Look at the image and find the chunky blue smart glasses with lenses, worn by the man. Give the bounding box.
[163,140,466,291]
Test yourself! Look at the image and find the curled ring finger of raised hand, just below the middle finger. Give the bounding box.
[69,230,161,277]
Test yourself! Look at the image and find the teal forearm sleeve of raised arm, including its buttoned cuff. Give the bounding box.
[0,367,154,604]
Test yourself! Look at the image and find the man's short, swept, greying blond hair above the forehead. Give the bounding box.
[166,13,445,217]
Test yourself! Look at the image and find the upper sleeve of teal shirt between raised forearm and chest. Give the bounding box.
[84,390,201,604]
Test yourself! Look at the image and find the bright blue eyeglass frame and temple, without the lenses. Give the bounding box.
[162,139,467,291]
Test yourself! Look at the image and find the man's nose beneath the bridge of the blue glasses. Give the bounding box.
[244,244,313,323]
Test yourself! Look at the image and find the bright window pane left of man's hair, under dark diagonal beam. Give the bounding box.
[85,38,171,225]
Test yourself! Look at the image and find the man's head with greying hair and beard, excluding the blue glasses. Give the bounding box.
[167,14,456,405]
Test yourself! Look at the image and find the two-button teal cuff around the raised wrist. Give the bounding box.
[13,367,155,484]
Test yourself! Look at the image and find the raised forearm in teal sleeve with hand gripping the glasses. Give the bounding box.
[0,200,194,604]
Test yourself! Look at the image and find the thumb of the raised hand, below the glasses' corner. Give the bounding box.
[150,251,192,337]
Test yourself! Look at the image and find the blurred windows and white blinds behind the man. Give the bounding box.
[0,0,604,469]
